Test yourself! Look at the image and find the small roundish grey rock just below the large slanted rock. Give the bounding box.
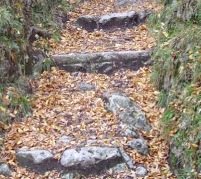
[128,139,149,155]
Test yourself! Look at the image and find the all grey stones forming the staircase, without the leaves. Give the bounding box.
[0,0,162,179]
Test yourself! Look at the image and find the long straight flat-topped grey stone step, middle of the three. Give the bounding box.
[52,51,150,74]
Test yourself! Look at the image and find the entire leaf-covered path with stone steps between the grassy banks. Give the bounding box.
[1,0,177,179]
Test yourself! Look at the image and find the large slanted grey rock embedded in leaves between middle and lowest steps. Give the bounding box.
[103,92,151,132]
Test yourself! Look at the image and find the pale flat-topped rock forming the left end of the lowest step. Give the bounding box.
[16,149,53,165]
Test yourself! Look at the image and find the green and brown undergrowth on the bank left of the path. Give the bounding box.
[0,0,70,131]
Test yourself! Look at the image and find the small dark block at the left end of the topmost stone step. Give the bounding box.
[77,15,98,32]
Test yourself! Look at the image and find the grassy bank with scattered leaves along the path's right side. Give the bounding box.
[149,0,201,179]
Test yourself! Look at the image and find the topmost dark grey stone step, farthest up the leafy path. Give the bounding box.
[76,10,151,32]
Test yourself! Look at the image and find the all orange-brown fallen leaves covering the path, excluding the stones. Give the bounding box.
[1,0,175,179]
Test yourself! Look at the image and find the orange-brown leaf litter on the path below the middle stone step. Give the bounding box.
[1,68,173,178]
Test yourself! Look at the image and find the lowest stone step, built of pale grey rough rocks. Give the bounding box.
[14,146,134,174]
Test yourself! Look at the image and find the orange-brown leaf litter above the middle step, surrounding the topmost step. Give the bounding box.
[50,0,162,54]
